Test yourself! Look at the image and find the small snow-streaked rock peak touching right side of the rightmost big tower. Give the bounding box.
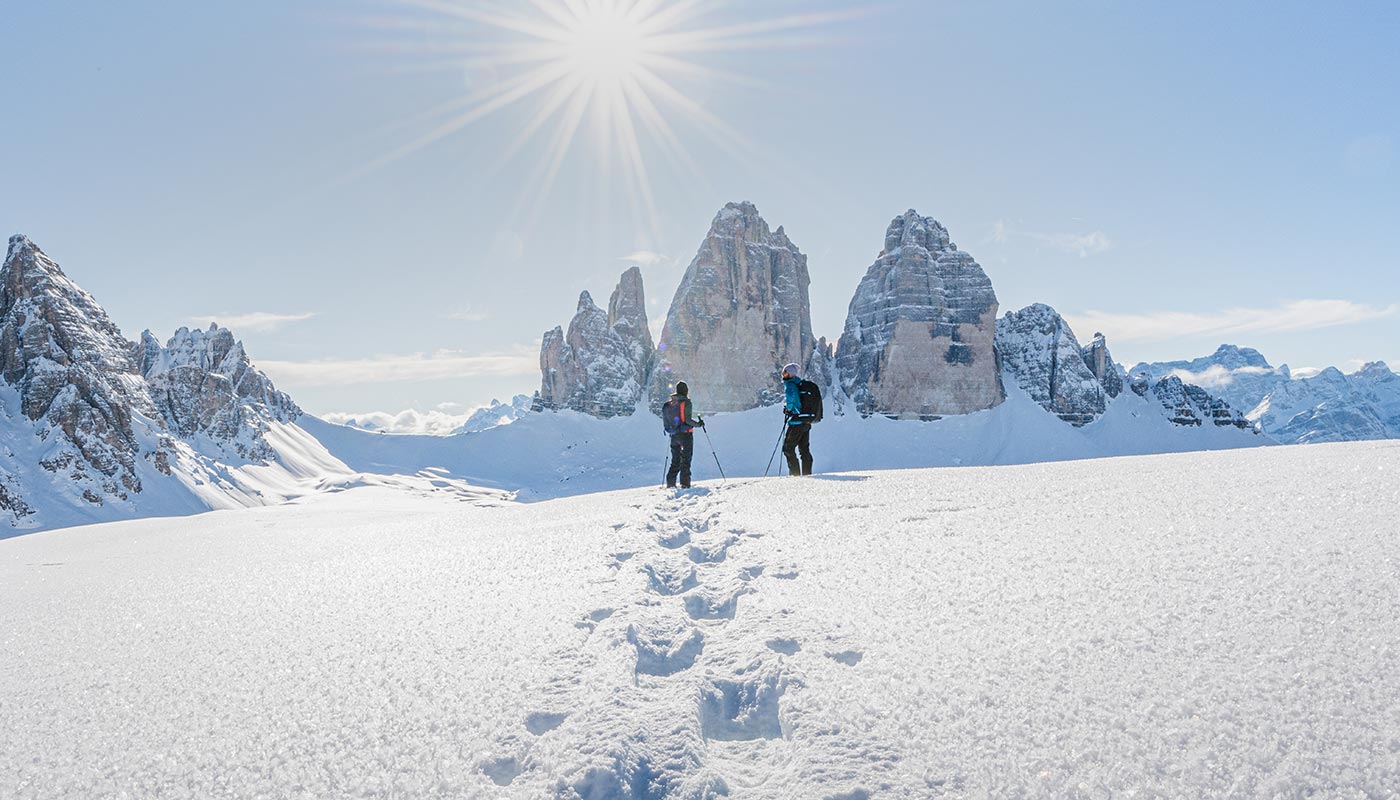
[997,303,1121,426]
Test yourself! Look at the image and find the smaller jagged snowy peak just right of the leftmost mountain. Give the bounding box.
[140,325,301,461]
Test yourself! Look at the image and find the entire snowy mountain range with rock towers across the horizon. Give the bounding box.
[0,203,1400,535]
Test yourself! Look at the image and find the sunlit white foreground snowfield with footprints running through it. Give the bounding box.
[0,443,1400,799]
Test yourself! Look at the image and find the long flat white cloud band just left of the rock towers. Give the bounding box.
[258,345,539,387]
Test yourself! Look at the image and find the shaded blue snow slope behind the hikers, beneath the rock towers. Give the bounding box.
[300,378,1270,500]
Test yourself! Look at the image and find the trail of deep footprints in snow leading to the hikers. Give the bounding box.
[479,490,893,800]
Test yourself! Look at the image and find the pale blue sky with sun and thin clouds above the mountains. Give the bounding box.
[0,0,1400,415]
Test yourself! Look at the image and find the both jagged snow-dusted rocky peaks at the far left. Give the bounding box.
[0,237,301,527]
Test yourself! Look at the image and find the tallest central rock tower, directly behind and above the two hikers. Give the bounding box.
[651,203,816,412]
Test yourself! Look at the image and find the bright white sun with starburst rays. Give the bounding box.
[358,0,862,236]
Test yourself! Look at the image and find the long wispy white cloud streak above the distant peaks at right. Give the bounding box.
[1070,300,1400,342]
